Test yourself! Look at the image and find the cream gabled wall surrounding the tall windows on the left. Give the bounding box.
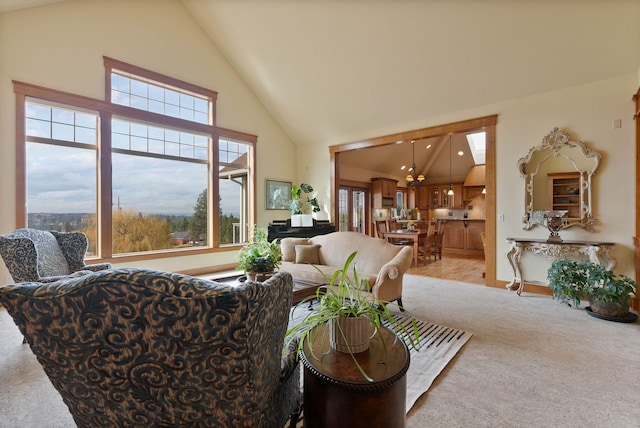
[0,0,296,283]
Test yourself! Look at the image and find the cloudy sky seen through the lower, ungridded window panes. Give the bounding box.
[27,143,240,215]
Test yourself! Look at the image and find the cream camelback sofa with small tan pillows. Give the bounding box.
[280,232,413,306]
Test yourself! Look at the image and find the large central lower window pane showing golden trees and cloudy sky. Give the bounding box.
[112,153,208,254]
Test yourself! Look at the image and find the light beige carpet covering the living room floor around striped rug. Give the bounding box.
[7,272,640,428]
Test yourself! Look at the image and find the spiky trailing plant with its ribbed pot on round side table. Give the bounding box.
[287,252,420,382]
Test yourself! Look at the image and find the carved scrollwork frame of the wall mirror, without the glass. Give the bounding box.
[518,127,602,232]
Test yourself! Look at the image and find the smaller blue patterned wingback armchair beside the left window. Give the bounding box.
[0,229,111,282]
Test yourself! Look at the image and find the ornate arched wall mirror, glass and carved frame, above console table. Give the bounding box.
[518,128,601,232]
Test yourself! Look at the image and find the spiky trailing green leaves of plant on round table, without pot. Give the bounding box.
[286,252,420,382]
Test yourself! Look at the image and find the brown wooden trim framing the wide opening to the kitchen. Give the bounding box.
[329,115,498,286]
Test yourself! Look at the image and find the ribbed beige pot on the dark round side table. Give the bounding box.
[329,317,373,354]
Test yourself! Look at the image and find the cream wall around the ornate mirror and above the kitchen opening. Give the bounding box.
[298,74,638,283]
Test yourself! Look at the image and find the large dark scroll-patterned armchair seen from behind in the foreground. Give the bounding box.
[0,269,300,428]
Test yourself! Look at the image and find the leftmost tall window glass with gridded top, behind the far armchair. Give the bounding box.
[25,101,98,257]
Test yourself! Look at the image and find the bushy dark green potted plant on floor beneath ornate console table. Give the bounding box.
[547,259,636,319]
